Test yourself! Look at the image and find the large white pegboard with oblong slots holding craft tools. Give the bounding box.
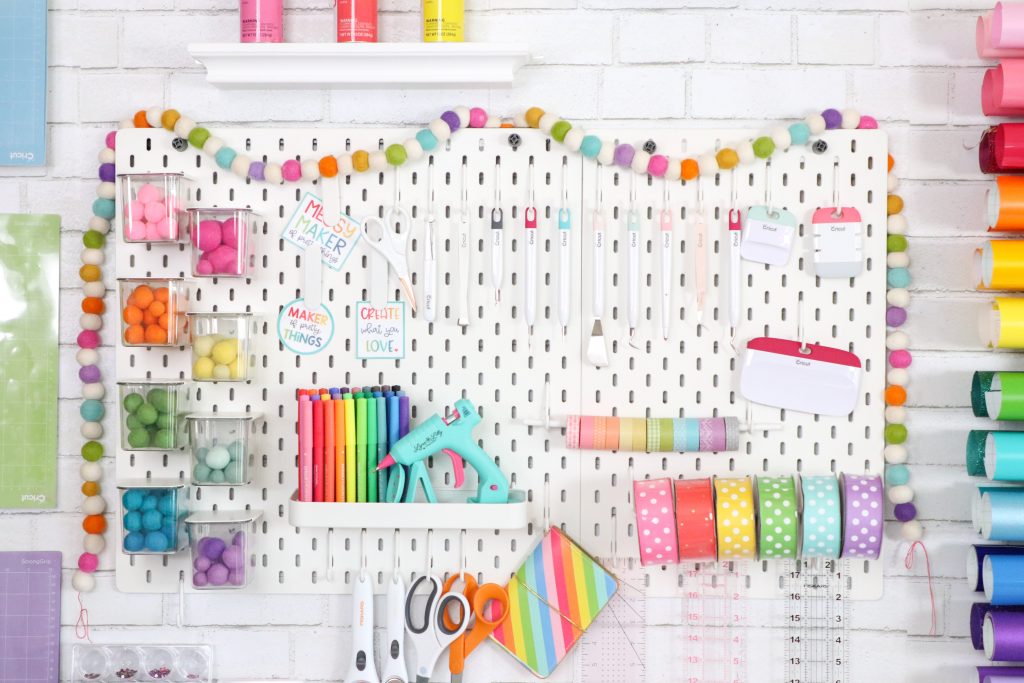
[110,129,887,598]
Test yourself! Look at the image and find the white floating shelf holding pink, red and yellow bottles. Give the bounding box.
[188,43,529,88]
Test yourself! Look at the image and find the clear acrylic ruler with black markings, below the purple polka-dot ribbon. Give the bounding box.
[782,559,851,683]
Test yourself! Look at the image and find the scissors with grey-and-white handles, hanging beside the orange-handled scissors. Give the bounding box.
[406,574,470,683]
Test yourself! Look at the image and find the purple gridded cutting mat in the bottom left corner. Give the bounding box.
[0,552,60,683]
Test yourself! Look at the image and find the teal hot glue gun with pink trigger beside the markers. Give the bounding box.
[377,398,509,503]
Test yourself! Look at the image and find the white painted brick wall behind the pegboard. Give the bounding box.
[0,0,999,682]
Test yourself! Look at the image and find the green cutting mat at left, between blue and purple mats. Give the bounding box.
[0,214,60,509]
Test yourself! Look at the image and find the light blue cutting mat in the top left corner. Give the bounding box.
[0,0,46,166]
